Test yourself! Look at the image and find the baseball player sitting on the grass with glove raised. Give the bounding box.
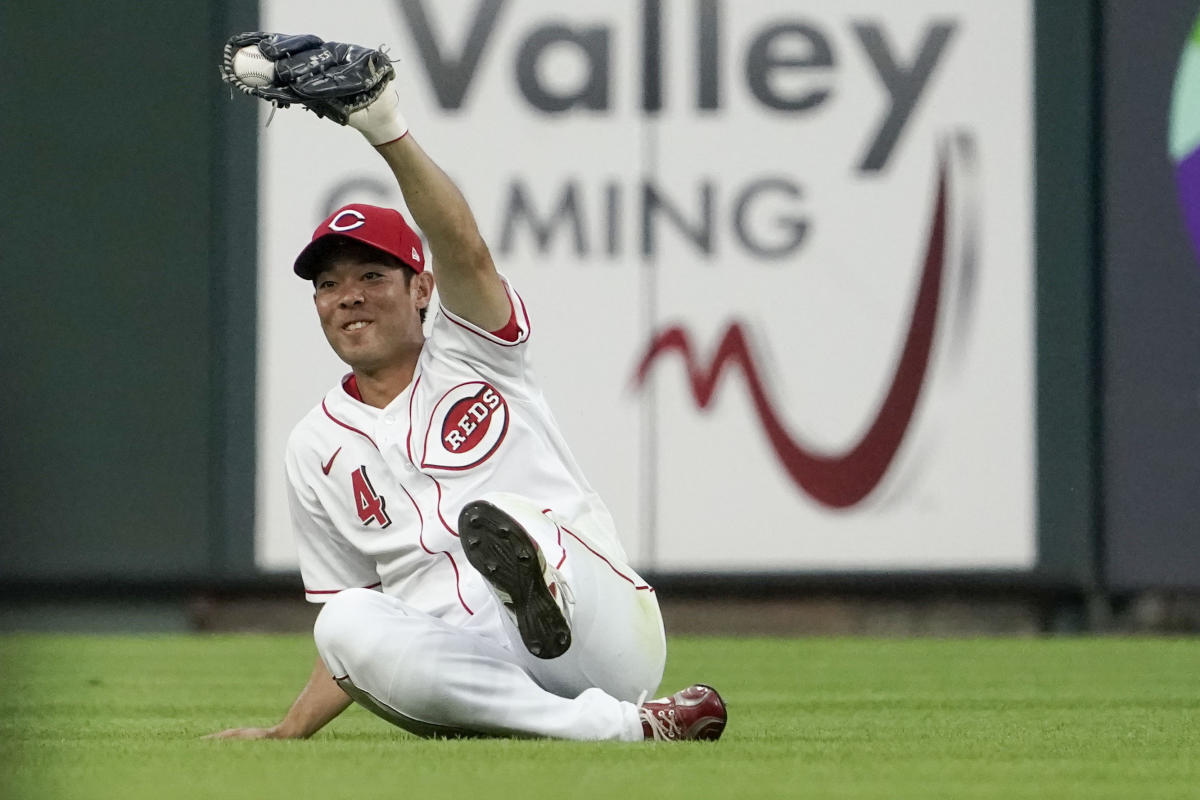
[214,34,726,740]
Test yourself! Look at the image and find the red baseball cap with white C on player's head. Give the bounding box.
[293,203,425,281]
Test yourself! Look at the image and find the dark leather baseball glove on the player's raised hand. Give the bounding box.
[221,31,396,125]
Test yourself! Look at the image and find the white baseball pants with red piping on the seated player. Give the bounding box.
[313,494,666,741]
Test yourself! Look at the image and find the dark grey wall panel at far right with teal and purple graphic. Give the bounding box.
[1099,0,1200,590]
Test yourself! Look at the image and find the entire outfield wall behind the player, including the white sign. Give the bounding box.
[0,0,1200,599]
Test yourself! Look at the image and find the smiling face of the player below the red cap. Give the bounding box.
[313,259,433,373]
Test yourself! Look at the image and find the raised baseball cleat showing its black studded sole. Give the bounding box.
[458,500,571,658]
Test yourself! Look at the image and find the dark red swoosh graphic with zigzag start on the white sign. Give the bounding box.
[635,157,946,509]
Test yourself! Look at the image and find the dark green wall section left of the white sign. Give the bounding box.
[0,0,257,581]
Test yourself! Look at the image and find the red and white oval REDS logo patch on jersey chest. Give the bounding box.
[421,380,509,470]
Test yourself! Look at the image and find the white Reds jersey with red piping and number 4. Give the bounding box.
[287,281,626,626]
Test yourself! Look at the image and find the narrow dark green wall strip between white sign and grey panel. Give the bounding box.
[1033,0,1100,591]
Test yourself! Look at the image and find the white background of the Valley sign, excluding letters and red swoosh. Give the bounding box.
[256,0,1036,572]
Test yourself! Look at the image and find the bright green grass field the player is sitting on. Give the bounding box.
[0,636,1200,800]
